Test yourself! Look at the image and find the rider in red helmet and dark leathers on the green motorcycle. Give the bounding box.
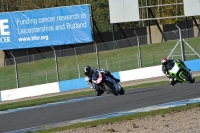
[161,57,191,86]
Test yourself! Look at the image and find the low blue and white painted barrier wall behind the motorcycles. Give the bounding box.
[0,59,200,101]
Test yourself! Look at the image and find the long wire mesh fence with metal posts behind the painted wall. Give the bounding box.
[0,29,200,90]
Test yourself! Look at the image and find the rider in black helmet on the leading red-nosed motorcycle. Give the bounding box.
[84,66,120,96]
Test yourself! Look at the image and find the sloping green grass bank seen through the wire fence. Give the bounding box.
[0,37,200,90]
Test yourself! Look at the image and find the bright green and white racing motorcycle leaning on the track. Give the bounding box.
[167,61,195,83]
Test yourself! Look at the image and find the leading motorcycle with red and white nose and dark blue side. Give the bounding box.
[92,71,125,96]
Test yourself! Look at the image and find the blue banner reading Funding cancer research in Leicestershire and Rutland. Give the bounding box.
[0,4,92,50]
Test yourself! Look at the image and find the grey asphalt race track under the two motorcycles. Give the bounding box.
[0,81,200,132]
